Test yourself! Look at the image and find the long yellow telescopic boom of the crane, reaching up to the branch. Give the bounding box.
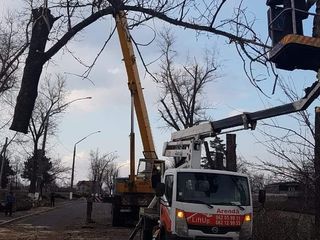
[116,11,155,158]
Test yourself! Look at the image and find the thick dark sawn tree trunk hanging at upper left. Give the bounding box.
[10,7,55,133]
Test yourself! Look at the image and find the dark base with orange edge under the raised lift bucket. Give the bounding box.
[269,34,320,71]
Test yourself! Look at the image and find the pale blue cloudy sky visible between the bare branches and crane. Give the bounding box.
[0,0,315,184]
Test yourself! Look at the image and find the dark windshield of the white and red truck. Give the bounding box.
[177,172,250,206]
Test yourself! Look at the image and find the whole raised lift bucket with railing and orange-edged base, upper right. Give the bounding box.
[267,0,320,71]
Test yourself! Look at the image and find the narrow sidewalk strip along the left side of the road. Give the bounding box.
[0,200,71,227]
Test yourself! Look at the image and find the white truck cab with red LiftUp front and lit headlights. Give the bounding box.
[160,168,253,240]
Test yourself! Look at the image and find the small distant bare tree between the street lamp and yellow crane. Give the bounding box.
[89,149,118,193]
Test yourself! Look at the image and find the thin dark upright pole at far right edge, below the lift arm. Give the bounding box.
[314,107,320,237]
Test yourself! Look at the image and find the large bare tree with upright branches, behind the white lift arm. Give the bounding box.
[155,31,218,130]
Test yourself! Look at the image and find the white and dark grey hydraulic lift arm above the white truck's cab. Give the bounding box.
[163,76,320,169]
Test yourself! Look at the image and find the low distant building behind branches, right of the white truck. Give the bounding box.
[265,182,303,197]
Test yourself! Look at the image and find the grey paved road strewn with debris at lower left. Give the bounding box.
[0,200,139,240]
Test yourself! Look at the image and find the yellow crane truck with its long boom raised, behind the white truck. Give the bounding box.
[112,8,164,226]
